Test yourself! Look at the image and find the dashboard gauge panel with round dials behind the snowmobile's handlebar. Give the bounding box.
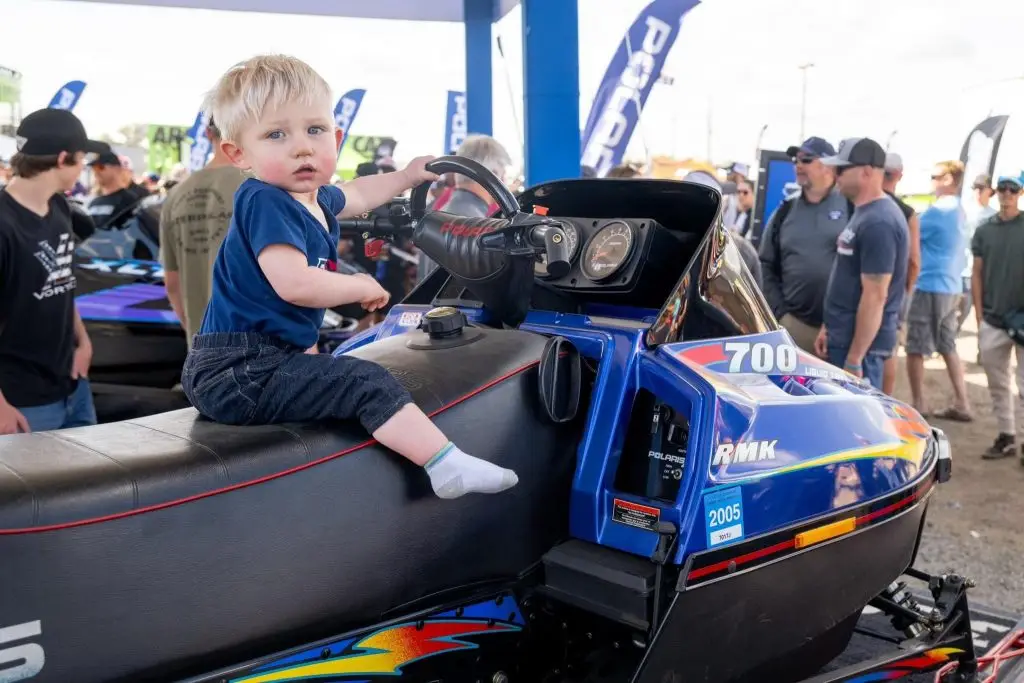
[534,218,651,290]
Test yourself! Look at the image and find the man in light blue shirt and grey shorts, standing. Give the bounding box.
[906,161,973,422]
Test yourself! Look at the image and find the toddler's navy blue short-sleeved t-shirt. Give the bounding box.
[200,178,345,349]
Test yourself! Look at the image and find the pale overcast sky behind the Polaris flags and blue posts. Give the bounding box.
[0,0,1024,189]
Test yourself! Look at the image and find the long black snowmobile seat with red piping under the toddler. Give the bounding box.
[0,330,579,683]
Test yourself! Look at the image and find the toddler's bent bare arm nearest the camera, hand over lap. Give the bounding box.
[257,245,387,308]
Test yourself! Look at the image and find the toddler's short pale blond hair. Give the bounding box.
[203,54,331,140]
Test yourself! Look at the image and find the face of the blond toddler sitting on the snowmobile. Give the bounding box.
[222,102,341,194]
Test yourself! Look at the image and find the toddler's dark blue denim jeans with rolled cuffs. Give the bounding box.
[181,332,413,433]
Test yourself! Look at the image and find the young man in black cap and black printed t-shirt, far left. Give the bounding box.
[0,109,110,434]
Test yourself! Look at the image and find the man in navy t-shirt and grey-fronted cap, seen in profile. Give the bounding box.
[814,137,909,390]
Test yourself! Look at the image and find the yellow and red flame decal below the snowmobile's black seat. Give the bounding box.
[234,620,519,683]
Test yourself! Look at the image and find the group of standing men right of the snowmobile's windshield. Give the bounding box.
[745,137,1024,462]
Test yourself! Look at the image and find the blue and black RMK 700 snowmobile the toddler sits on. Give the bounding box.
[0,157,991,683]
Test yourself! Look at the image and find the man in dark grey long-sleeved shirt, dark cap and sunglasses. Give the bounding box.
[760,137,851,352]
